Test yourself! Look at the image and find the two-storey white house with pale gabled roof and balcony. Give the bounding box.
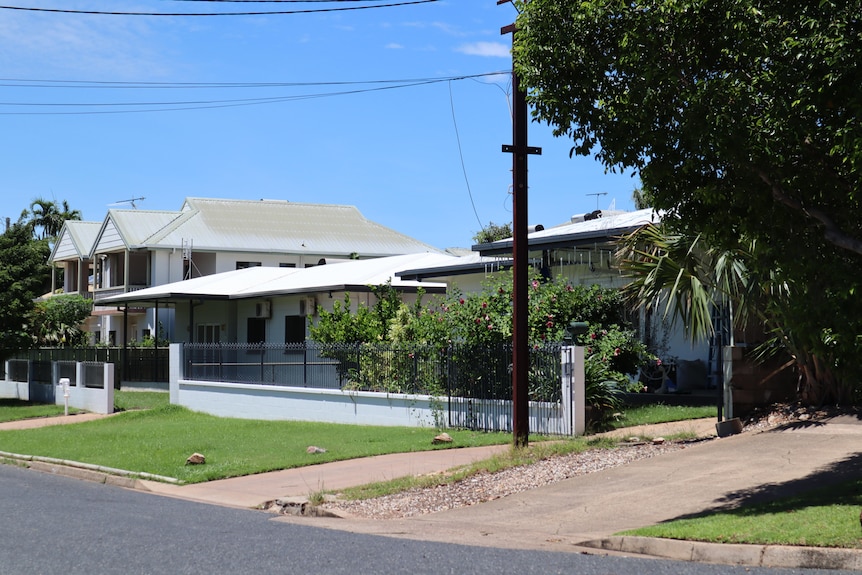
[49,198,439,345]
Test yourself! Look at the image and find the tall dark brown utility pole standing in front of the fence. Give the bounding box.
[498,11,542,447]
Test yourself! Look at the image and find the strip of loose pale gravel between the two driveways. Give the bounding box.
[323,443,686,519]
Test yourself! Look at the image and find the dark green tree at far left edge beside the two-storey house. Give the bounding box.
[0,220,51,349]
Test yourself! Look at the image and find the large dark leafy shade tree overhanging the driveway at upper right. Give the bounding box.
[514,0,862,402]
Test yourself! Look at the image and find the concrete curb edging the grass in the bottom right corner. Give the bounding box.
[578,536,862,571]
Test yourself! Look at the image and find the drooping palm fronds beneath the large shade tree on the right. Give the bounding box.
[618,223,853,404]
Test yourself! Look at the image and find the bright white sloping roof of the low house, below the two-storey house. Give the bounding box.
[100,254,457,304]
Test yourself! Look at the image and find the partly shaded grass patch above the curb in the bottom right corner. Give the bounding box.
[621,479,862,549]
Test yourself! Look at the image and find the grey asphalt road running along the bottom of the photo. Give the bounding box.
[0,465,850,575]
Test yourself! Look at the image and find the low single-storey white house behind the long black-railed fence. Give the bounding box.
[103,253,457,343]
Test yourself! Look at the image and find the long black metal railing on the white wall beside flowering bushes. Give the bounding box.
[183,343,563,431]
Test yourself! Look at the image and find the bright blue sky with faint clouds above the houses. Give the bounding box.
[0,0,639,248]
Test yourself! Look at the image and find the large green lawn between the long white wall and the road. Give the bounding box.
[0,402,511,483]
